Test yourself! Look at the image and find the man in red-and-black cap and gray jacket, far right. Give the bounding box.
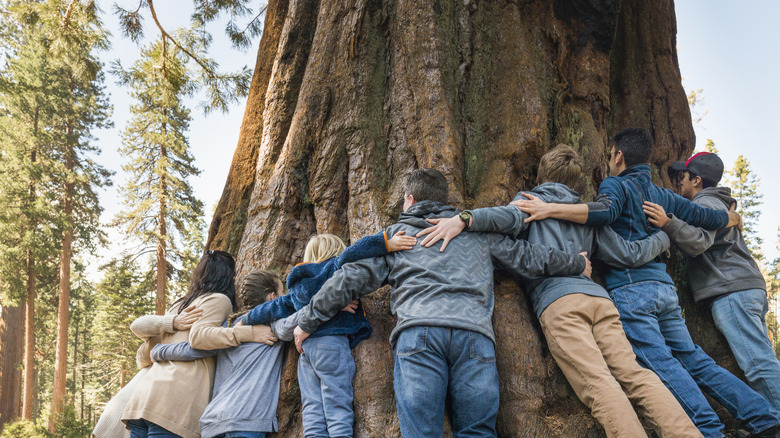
[645,152,780,418]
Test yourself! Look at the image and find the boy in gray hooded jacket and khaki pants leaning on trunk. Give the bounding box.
[418,145,701,438]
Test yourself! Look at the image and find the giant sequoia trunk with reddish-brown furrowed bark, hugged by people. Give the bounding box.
[209,0,744,437]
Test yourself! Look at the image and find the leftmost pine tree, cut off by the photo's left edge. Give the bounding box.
[0,3,68,420]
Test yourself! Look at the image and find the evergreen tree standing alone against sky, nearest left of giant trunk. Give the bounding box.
[114,35,205,315]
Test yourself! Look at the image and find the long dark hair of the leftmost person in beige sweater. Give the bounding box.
[173,250,236,313]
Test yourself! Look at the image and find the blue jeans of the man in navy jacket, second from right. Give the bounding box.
[609,281,778,437]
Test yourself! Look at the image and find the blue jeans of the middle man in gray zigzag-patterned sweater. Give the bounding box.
[393,326,498,438]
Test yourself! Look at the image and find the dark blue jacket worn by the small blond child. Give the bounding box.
[244,231,388,348]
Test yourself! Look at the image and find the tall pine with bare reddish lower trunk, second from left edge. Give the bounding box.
[5,0,110,430]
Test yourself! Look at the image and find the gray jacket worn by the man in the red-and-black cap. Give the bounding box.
[664,187,766,303]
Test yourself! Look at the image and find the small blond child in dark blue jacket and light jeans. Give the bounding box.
[244,231,417,437]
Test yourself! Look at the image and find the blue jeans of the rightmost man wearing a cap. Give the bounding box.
[712,289,780,418]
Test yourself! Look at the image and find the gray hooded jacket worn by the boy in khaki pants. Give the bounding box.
[470,183,669,317]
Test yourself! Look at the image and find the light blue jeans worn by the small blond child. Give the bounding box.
[298,336,355,438]
